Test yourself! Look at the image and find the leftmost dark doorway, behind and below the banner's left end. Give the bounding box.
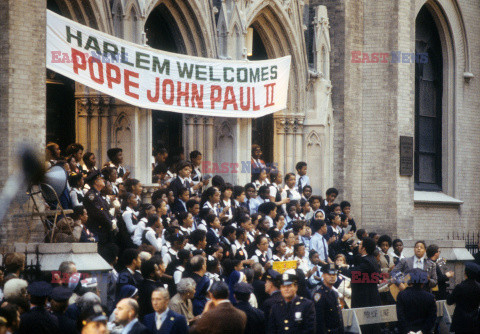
[46,0,75,151]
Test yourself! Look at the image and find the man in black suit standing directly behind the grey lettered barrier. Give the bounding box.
[350,237,381,334]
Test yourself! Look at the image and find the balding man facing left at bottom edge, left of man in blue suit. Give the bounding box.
[114,298,150,334]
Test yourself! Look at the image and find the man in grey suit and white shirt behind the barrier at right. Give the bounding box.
[392,240,437,292]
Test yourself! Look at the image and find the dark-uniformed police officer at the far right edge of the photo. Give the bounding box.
[447,262,480,333]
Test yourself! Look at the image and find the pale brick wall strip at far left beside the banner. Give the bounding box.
[0,0,46,245]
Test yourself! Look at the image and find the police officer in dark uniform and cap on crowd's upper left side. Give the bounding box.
[83,170,116,245]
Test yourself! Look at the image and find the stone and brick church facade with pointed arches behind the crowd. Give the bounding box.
[0,0,480,243]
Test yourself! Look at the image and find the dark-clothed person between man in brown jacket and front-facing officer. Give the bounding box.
[234,282,265,334]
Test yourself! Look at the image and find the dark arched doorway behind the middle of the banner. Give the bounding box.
[145,4,186,152]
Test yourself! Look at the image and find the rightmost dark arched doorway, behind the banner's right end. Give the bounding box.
[248,28,273,163]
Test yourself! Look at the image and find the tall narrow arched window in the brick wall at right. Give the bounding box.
[415,6,443,191]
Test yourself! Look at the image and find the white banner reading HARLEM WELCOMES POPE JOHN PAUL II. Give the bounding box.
[47,10,291,118]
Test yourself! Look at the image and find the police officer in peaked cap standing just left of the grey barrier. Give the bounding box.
[313,263,344,334]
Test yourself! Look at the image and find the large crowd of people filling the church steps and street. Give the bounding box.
[0,143,480,334]
